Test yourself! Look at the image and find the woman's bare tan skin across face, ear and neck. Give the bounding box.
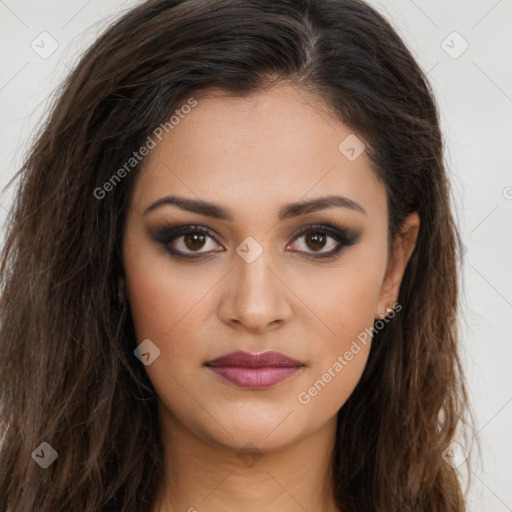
[122,85,419,512]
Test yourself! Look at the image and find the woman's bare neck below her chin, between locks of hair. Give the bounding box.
[154,407,339,512]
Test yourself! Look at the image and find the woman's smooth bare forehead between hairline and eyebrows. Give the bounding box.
[133,85,386,223]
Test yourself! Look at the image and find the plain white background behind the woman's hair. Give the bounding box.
[0,0,512,512]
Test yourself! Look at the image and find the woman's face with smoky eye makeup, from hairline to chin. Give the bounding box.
[123,85,418,451]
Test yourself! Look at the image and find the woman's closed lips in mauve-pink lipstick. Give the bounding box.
[205,351,305,389]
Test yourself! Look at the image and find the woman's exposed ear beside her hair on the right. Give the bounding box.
[375,212,420,318]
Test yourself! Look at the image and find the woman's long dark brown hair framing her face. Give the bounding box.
[0,0,470,512]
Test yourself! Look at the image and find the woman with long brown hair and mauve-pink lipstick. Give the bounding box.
[0,0,474,512]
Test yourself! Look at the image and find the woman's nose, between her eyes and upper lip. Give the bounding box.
[219,247,292,333]
